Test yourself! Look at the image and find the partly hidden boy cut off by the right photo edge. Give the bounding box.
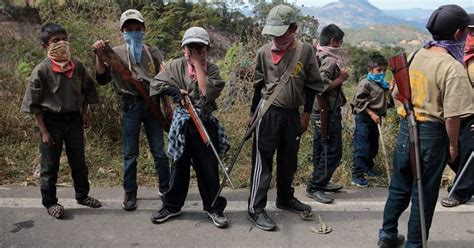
[441,14,474,207]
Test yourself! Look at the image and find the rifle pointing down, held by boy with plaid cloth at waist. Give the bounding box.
[183,95,235,188]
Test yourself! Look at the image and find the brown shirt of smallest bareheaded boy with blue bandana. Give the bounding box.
[351,78,392,116]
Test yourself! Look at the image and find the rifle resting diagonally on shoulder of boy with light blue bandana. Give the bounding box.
[94,45,171,132]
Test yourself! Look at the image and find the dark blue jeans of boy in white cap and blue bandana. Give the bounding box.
[122,95,170,192]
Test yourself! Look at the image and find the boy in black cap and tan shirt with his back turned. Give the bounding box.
[377,5,473,247]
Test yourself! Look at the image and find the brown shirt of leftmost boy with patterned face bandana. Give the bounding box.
[21,59,99,113]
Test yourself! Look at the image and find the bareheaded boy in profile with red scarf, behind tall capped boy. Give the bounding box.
[306,24,349,204]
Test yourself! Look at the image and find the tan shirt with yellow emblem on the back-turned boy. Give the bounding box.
[398,49,474,122]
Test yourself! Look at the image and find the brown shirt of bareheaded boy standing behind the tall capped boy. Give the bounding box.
[313,51,347,111]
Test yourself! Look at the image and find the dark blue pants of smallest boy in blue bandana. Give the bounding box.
[352,113,379,177]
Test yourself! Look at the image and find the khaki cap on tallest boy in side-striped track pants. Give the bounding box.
[262,4,296,37]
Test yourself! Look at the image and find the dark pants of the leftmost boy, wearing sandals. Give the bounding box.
[40,112,89,208]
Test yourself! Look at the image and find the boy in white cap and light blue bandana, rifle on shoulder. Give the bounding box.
[93,9,171,211]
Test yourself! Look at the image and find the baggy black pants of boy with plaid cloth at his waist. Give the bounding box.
[162,120,227,213]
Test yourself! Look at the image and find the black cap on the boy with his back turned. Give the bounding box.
[426,4,469,40]
